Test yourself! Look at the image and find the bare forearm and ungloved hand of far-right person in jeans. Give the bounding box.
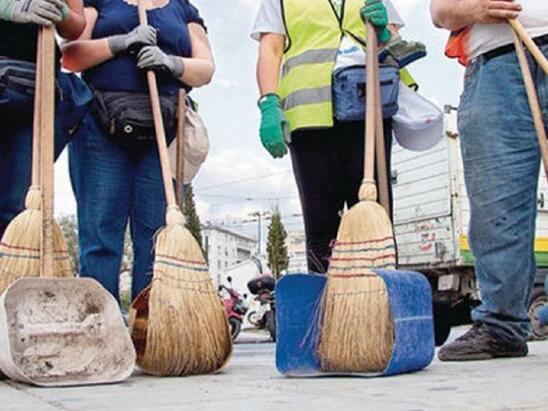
[430,0,521,31]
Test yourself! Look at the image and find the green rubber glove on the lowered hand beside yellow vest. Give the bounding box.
[259,94,290,158]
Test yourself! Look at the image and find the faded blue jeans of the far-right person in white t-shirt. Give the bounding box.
[459,47,548,342]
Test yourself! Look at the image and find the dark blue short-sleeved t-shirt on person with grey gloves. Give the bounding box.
[84,0,205,95]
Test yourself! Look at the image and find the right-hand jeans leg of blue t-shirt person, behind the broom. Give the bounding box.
[130,150,167,299]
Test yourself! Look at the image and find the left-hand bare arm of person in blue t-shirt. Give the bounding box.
[62,7,114,71]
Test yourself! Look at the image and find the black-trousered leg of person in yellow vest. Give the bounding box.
[290,129,344,273]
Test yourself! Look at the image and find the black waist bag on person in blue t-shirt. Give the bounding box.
[92,90,177,155]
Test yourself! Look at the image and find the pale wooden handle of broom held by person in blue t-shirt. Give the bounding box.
[137,0,177,208]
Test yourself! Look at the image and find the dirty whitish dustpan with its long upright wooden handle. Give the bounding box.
[0,27,135,387]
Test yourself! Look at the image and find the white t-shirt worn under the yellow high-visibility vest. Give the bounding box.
[251,0,402,70]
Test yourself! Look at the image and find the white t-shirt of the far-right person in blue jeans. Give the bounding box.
[468,0,548,59]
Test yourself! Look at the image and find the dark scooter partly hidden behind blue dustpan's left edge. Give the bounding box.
[247,274,276,342]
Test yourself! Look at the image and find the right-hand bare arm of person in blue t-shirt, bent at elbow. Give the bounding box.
[180,23,215,87]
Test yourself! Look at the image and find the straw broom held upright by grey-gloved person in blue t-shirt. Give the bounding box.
[138,0,232,376]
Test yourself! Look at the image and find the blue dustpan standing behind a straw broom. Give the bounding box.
[276,270,435,377]
